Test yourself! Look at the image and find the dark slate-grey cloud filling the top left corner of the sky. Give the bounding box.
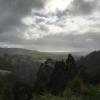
[0,0,45,33]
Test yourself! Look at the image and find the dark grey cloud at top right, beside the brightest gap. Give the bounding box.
[56,0,97,18]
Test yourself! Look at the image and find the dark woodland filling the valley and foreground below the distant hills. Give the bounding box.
[0,48,100,100]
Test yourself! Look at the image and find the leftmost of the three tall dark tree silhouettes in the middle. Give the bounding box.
[35,59,54,94]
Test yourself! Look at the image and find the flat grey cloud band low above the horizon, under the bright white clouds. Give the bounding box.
[27,33,100,51]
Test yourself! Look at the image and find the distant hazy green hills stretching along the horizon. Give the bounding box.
[0,48,86,61]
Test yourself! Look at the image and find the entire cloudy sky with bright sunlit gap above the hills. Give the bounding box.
[0,0,100,52]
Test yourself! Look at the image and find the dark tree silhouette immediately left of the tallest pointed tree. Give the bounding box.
[50,60,67,95]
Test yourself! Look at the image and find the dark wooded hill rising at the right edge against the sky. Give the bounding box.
[80,51,100,78]
